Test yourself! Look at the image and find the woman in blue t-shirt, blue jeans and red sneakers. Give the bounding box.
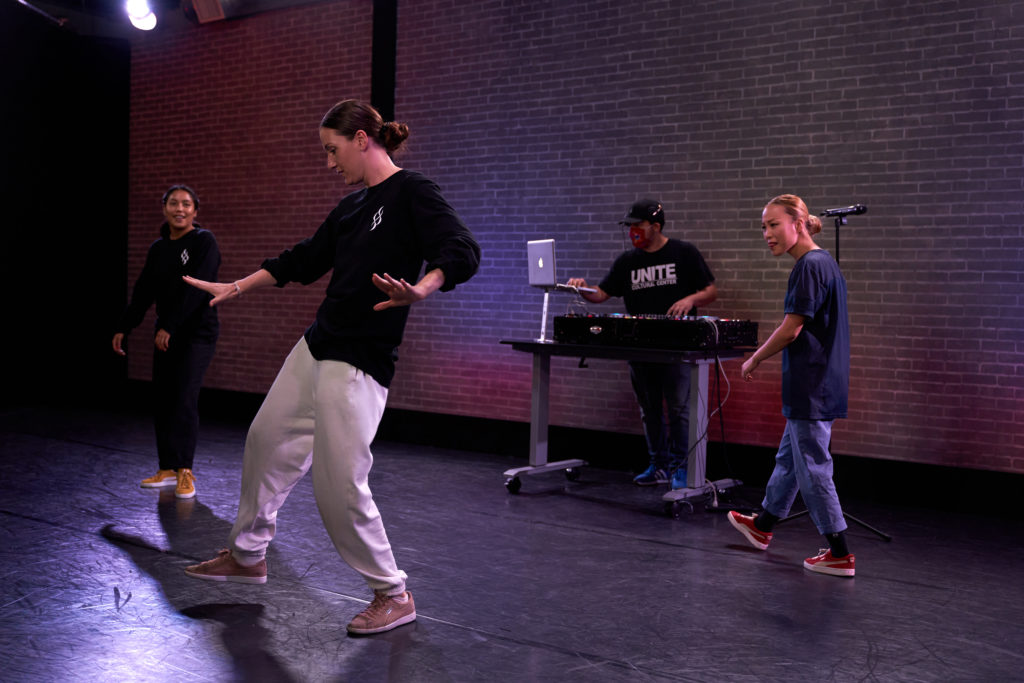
[729,195,855,577]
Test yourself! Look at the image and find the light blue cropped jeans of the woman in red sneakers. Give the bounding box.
[761,419,846,535]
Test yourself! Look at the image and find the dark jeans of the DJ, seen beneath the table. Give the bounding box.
[630,361,690,469]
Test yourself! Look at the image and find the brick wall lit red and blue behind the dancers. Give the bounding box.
[123,0,1024,472]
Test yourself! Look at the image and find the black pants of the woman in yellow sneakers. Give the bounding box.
[153,340,215,470]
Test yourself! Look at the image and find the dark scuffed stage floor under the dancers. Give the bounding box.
[0,407,1024,682]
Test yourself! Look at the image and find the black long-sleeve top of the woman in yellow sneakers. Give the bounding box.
[117,223,220,344]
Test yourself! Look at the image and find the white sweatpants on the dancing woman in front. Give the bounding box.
[229,339,407,595]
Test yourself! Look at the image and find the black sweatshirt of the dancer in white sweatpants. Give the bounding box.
[261,170,480,387]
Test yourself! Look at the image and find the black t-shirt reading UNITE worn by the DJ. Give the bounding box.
[600,239,715,315]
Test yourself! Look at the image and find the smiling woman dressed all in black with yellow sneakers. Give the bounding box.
[113,185,220,498]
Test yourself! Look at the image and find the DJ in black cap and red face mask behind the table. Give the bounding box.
[567,200,718,488]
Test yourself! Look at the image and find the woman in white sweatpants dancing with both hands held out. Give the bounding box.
[185,99,480,634]
